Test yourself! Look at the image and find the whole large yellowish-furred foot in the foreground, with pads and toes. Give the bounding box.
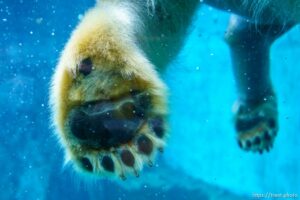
[50,7,167,179]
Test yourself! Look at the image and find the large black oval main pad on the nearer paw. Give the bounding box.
[69,101,143,150]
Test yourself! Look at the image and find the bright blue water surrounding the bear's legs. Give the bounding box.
[0,0,300,200]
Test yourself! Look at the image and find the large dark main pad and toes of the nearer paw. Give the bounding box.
[69,94,165,180]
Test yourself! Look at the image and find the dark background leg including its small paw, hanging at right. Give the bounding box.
[225,15,293,153]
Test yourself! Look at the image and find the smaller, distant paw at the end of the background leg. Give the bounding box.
[234,96,278,154]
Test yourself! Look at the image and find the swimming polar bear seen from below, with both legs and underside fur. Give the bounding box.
[50,0,300,179]
